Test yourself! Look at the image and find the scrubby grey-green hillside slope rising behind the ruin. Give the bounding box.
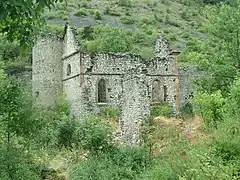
[43,0,210,59]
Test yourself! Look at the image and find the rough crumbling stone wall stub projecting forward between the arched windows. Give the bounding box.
[120,73,150,145]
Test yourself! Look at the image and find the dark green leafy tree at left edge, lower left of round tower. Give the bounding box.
[0,76,37,141]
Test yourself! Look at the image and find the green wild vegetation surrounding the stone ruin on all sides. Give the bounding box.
[0,0,240,180]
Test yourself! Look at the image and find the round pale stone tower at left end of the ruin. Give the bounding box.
[32,36,63,107]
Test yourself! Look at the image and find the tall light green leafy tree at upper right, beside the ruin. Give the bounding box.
[183,0,240,96]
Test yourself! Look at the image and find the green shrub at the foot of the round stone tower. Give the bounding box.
[34,95,71,148]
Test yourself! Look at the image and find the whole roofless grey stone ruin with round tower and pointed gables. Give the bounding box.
[32,25,194,145]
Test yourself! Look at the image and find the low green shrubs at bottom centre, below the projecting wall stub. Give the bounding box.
[70,148,149,180]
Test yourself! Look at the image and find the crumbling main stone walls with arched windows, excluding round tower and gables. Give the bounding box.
[63,52,180,144]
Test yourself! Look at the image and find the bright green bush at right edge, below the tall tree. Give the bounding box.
[214,79,240,162]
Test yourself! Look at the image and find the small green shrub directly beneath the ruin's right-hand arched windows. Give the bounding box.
[150,104,172,117]
